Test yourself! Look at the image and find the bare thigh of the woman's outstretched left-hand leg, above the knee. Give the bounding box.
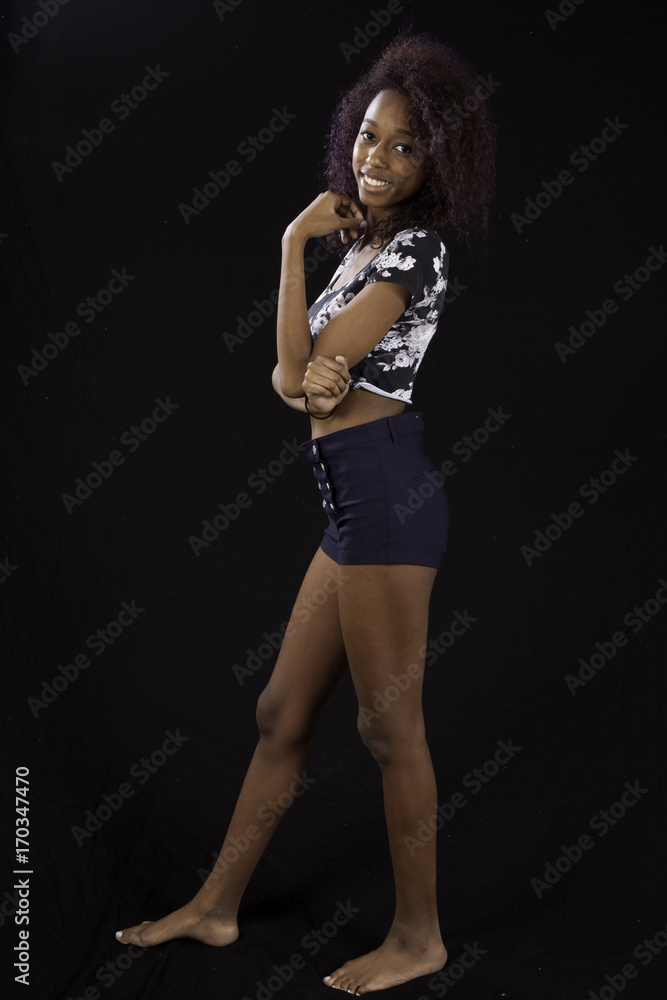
[261,549,347,724]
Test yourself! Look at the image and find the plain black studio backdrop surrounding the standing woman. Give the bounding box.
[0,0,667,1000]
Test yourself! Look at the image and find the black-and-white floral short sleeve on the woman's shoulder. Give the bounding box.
[366,229,448,306]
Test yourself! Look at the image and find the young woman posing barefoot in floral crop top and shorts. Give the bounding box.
[117,35,494,994]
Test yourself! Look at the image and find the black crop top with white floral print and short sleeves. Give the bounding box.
[308,229,449,403]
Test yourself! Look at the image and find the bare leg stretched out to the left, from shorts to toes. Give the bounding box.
[119,549,347,947]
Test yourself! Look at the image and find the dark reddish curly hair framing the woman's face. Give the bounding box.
[324,33,496,249]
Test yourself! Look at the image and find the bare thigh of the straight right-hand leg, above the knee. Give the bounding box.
[338,564,436,724]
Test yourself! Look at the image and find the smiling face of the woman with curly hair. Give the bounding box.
[352,90,424,223]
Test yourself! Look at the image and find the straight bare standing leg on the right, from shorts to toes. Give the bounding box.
[325,565,447,994]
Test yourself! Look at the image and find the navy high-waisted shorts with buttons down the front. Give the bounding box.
[300,411,449,569]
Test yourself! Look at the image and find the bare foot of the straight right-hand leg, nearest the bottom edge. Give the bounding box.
[324,935,447,996]
